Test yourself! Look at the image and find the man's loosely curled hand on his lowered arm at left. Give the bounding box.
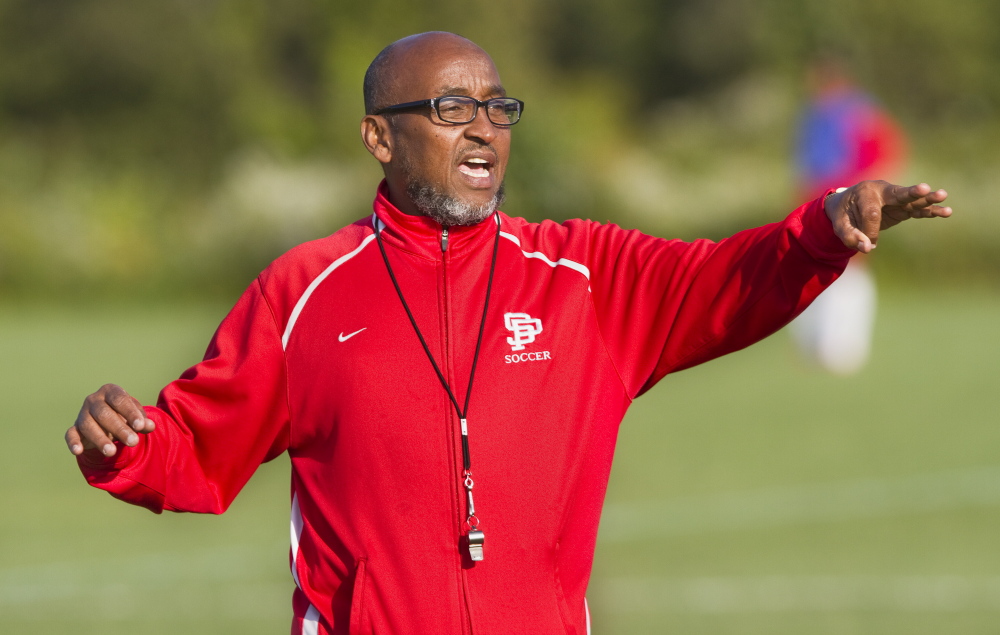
[66,384,156,456]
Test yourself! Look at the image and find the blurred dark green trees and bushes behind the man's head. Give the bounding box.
[0,0,1000,293]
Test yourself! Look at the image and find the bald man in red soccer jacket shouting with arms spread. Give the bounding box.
[66,33,951,634]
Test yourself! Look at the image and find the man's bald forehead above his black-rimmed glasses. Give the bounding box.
[392,41,506,103]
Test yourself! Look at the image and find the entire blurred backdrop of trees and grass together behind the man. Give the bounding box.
[0,0,1000,634]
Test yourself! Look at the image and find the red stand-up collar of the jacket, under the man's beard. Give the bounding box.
[372,180,504,260]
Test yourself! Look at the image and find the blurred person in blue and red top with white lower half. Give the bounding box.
[792,57,906,375]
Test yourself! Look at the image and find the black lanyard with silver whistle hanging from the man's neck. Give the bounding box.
[375,212,500,561]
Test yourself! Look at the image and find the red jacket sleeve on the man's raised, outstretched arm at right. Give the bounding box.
[590,198,854,397]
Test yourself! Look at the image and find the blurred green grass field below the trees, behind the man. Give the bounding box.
[0,291,1000,635]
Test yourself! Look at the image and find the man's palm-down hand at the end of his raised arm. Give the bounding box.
[824,181,951,254]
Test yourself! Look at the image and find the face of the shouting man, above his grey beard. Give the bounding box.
[368,37,510,224]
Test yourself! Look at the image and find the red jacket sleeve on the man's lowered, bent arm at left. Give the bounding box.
[77,279,289,514]
